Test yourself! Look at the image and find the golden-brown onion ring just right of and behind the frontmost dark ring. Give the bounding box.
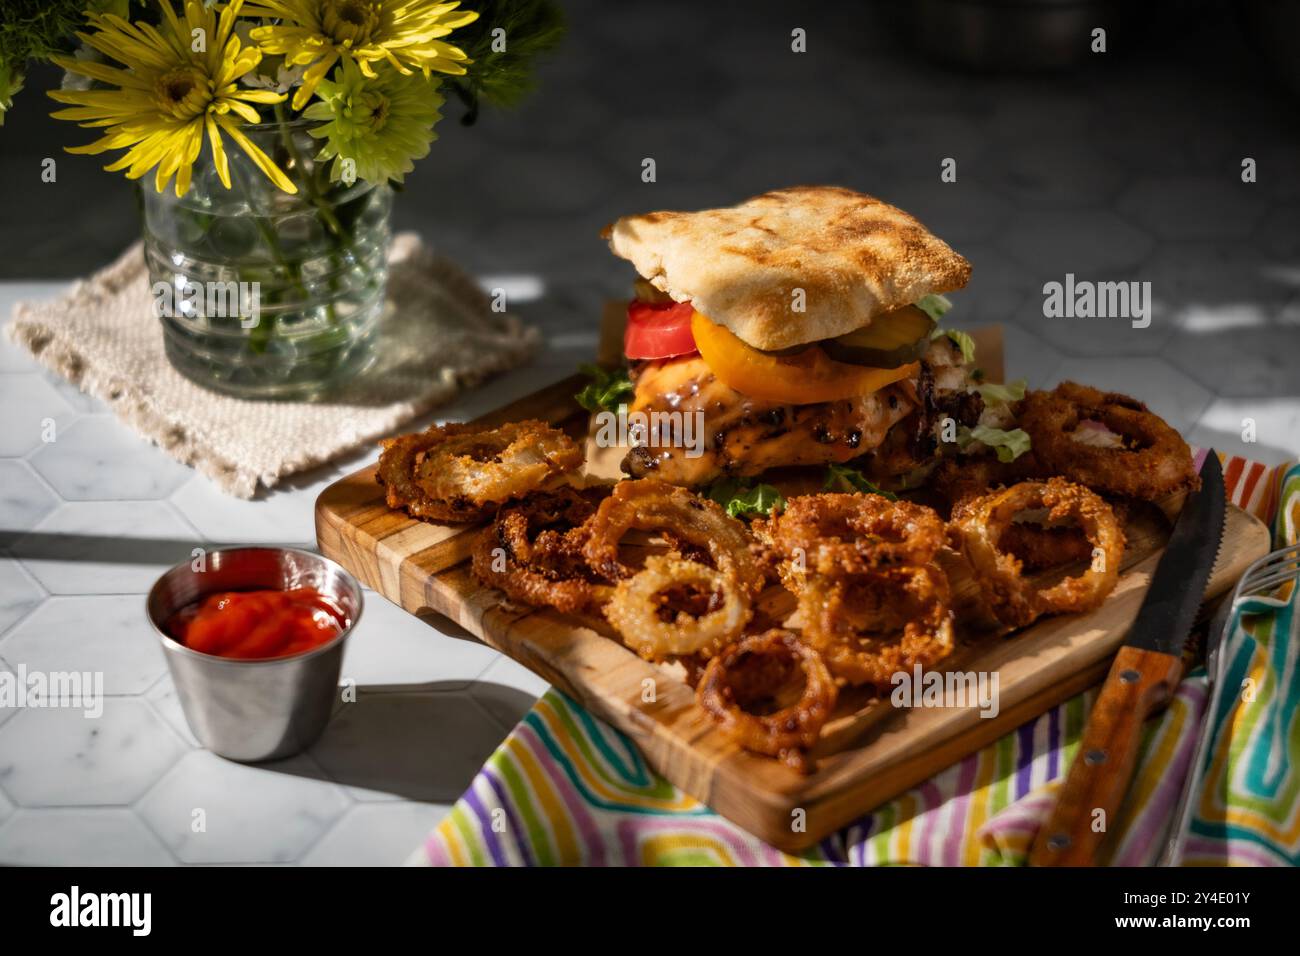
[800,564,954,691]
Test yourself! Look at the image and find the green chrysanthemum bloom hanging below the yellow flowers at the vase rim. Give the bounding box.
[303,60,442,183]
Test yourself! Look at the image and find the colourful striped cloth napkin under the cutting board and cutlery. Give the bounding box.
[410,453,1300,866]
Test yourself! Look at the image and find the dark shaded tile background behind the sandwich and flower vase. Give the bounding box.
[0,0,1300,460]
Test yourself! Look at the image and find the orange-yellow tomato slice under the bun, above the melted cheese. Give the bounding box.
[690,312,919,405]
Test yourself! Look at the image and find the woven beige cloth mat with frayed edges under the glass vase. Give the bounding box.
[8,233,541,498]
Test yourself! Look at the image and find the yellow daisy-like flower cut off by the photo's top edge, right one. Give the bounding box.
[244,0,478,109]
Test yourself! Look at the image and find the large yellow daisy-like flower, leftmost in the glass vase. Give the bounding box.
[49,0,298,196]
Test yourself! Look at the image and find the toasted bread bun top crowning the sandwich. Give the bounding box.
[603,186,971,350]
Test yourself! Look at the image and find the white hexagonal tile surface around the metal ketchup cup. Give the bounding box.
[0,285,546,865]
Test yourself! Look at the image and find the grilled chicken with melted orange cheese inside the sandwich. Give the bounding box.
[623,356,917,485]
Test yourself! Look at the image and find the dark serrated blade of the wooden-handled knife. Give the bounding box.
[1125,450,1227,657]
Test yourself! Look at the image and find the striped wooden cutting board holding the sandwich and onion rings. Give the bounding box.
[316,314,1269,851]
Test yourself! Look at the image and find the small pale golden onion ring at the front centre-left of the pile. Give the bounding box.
[605,554,750,661]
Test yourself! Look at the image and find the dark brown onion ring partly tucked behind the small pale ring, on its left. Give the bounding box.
[471,488,614,614]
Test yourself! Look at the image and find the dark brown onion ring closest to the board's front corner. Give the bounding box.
[696,630,836,773]
